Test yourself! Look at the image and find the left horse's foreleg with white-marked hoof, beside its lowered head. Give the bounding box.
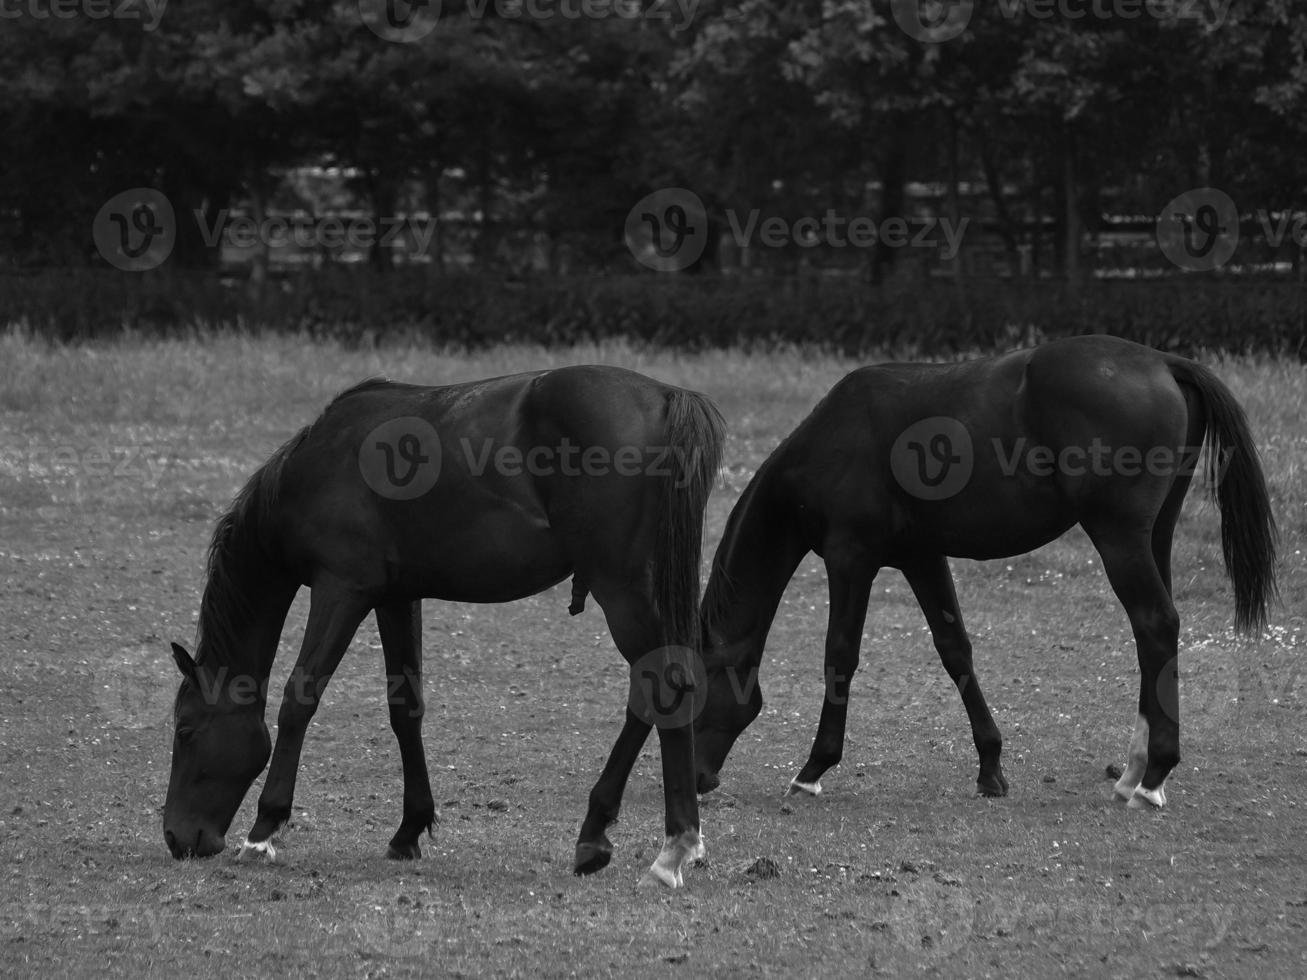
[240,584,370,860]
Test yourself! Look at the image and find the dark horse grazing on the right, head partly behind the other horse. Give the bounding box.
[695,337,1276,806]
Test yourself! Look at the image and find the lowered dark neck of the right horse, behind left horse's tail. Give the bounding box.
[703,460,809,666]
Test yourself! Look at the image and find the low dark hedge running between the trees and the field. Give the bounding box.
[0,269,1307,359]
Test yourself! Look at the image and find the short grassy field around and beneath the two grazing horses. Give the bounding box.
[0,335,1307,977]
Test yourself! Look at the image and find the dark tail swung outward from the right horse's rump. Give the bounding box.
[1166,355,1278,631]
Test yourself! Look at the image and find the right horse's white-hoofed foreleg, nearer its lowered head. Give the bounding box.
[788,546,880,796]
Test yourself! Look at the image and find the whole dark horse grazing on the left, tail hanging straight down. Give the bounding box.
[163,367,723,887]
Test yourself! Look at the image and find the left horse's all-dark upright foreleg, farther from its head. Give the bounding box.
[376,602,435,860]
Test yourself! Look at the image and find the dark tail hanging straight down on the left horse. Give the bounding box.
[654,388,725,651]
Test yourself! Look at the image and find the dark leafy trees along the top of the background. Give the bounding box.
[0,0,1307,281]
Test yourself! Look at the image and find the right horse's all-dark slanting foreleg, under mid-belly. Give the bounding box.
[903,555,1008,796]
